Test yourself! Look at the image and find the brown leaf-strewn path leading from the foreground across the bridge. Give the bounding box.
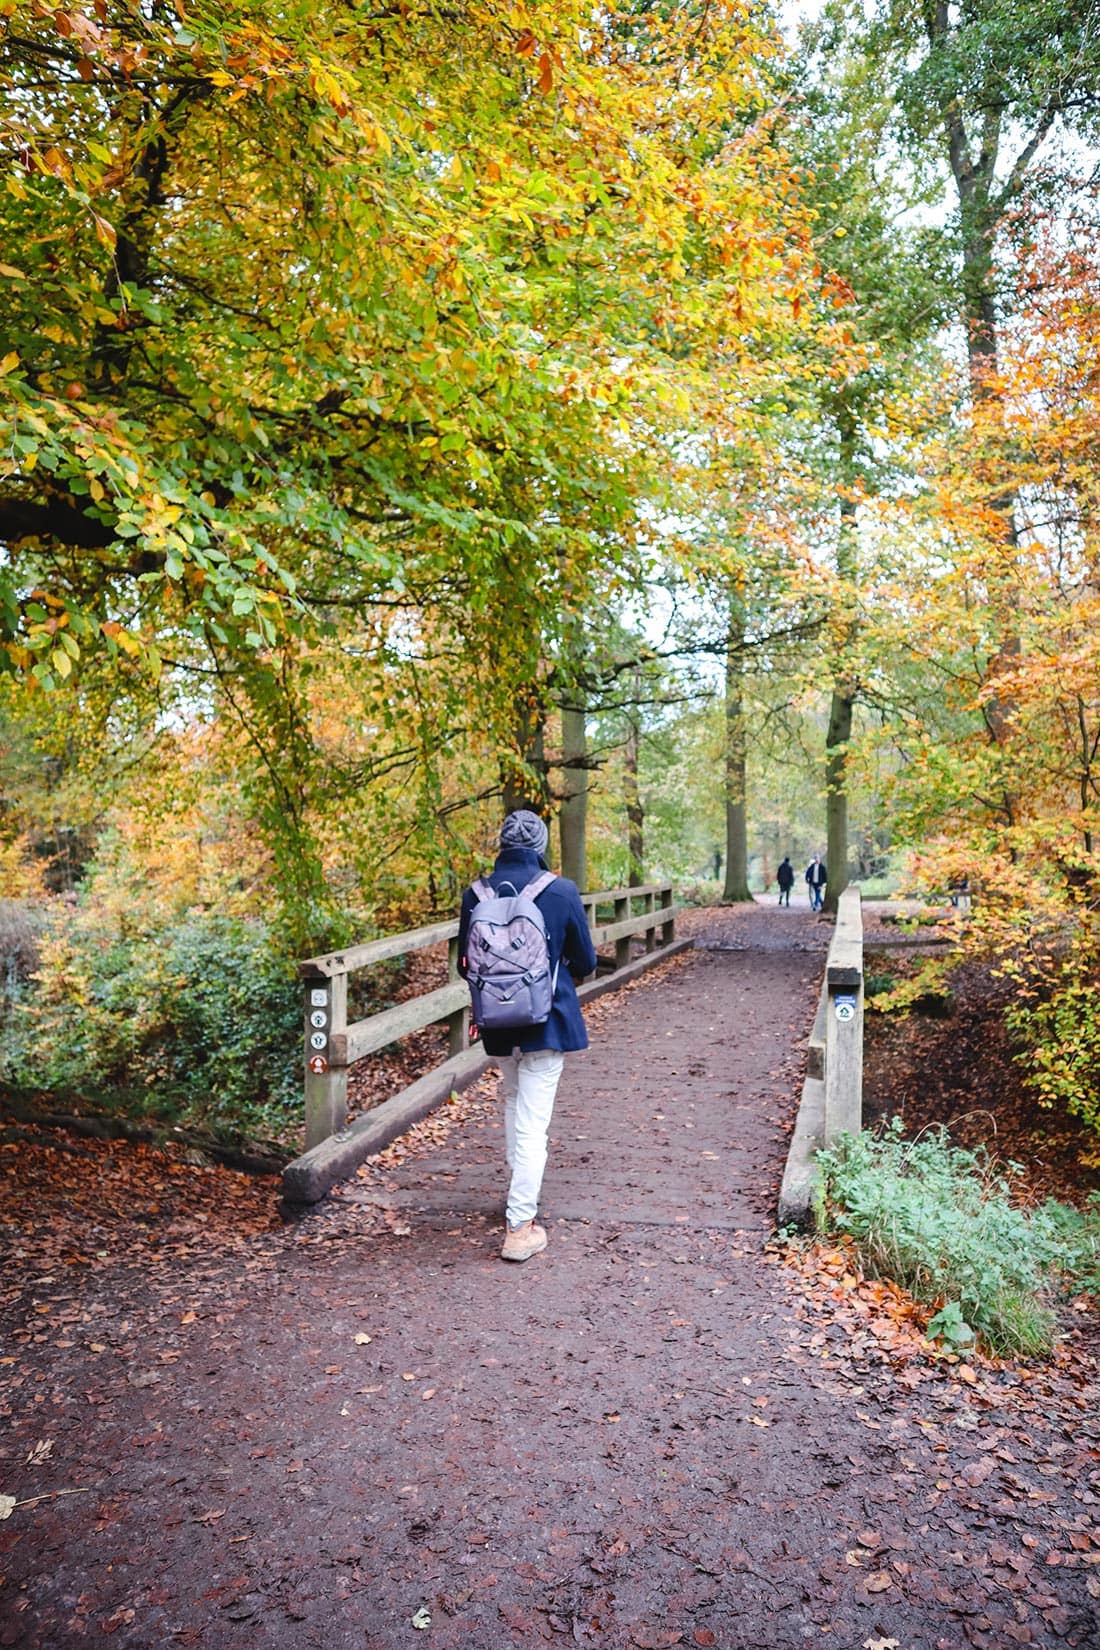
[0,911,1100,1650]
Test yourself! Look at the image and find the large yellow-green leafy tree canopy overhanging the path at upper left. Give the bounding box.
[0,0,817,934]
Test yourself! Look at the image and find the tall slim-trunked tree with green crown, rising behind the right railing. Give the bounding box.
[792,12,950,911]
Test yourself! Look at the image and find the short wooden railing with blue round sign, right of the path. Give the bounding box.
[778,884,863,1226]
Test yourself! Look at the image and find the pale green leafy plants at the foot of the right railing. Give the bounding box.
[818,1119,1100,1356]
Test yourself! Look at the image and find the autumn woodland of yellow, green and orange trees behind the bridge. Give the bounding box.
[0,0,1100,1161]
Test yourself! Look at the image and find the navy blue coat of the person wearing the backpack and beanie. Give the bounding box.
[458,848,595,1054]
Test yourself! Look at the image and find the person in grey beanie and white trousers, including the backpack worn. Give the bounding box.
[458,809,595,1261]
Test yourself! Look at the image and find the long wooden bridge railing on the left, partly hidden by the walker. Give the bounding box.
[284,883,678,1203]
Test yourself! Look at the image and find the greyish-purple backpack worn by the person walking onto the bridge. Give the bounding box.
[467,871,557,1031]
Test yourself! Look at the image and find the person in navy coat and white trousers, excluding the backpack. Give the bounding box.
[458,809,595,1261]
